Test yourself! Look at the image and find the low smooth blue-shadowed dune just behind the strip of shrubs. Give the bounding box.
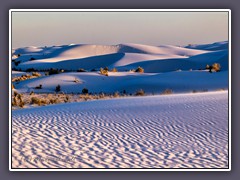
[14,71,228,94]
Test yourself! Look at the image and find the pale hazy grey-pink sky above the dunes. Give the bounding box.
[12,12,228,48]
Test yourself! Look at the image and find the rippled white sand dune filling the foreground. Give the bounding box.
[12,91,228,168]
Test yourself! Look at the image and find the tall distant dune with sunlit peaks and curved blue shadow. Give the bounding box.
[13,44,212,70]
